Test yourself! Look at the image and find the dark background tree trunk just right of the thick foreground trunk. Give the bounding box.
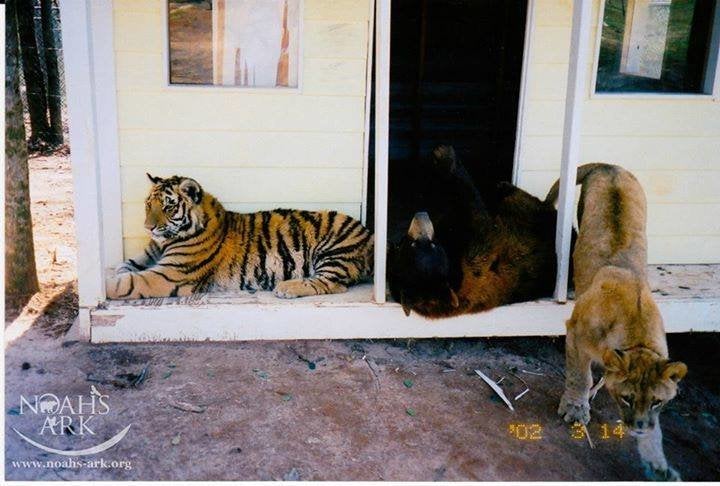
[14,0,50,144]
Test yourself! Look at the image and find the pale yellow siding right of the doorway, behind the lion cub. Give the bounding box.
[518,0,720,263]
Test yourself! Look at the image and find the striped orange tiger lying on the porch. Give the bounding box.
[106,174,374,299]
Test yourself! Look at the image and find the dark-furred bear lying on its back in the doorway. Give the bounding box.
[388,146,557,318]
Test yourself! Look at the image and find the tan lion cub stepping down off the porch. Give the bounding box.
[551,164,687,480]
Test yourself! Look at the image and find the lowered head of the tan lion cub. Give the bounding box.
[603,348,687,435]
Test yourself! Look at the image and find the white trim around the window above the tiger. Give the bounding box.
[160,0,305,95]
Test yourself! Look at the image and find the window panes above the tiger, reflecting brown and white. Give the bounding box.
[167,0,301,88]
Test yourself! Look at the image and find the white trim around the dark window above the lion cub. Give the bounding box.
[590,0,720,101]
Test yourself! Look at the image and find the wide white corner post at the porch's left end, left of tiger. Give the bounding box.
[60,0,105,338]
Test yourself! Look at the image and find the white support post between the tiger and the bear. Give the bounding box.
[374,0,391,304]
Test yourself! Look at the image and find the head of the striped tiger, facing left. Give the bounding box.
[145,174,205,243]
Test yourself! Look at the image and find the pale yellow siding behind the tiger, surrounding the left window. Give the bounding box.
[113,0,370,256]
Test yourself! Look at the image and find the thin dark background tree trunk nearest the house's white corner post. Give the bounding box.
[40,0,63,145]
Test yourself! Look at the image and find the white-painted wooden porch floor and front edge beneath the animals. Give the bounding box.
[90,265,720,342]
